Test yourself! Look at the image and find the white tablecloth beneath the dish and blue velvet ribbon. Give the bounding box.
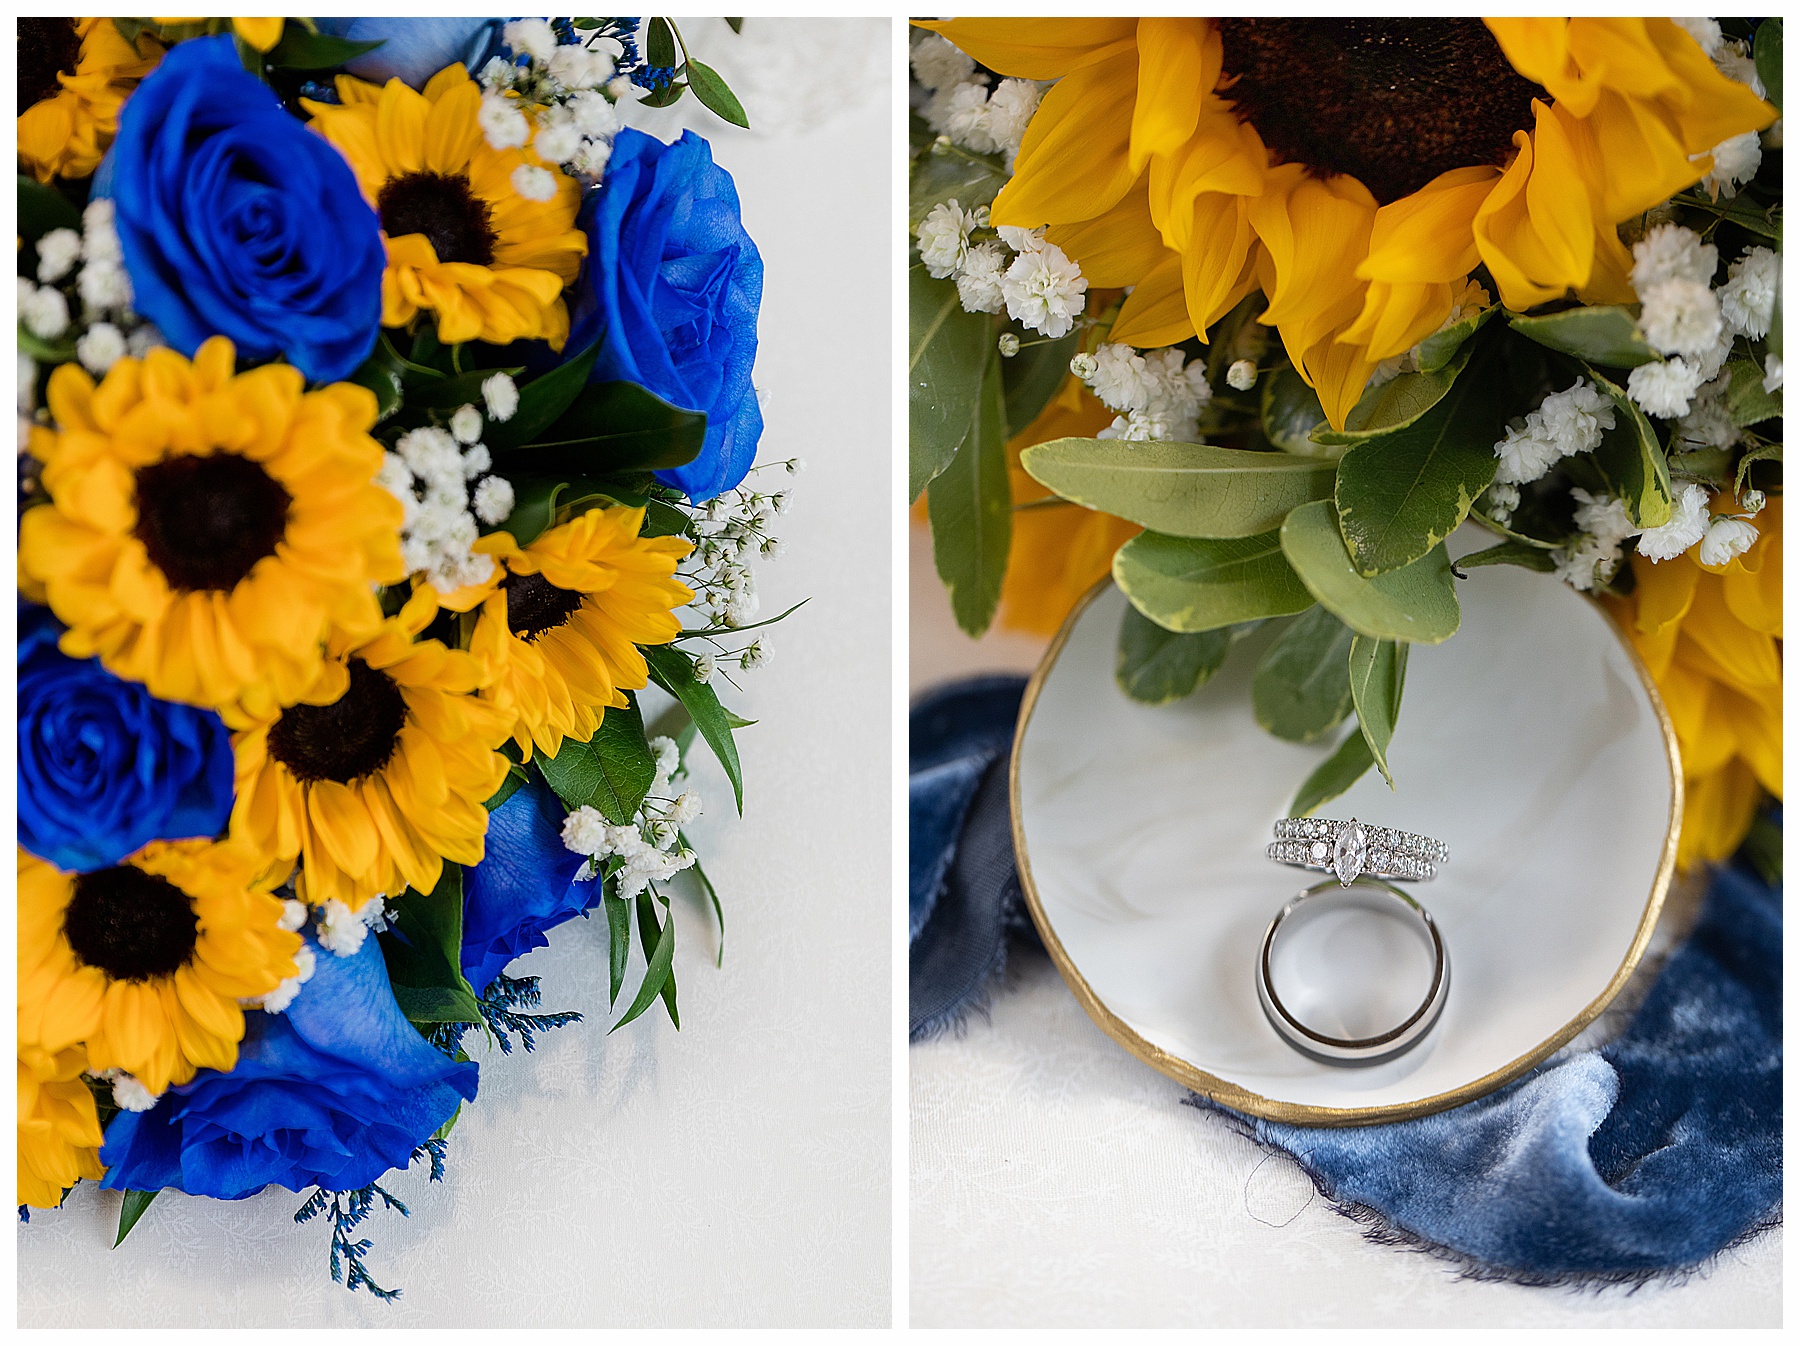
[909,527,1782,1328]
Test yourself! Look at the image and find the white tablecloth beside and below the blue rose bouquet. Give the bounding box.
[18,18,893,1328]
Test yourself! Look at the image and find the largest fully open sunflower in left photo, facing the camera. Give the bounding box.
[18,337,405,709]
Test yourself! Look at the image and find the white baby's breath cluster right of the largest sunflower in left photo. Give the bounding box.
[376,394,518,594]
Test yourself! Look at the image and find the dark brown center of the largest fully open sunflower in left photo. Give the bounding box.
[133,453,293,590]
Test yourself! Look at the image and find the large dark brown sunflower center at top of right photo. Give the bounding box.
[1219,18,1548,205]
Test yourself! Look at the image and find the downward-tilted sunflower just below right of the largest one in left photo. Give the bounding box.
[225,587,511,909]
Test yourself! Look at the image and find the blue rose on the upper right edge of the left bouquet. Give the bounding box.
[565,128,763,500]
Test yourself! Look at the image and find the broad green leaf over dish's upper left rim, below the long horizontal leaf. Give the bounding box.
[1112,531,1312,633]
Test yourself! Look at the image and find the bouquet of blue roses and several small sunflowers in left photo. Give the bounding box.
[18,18,797,1297]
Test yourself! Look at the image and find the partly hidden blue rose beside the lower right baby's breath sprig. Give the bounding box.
[463,776,601,995]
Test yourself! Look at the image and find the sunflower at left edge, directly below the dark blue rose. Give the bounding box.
[18,839,301,1094]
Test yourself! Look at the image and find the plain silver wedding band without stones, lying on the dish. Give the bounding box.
[1256,876,1451,1065]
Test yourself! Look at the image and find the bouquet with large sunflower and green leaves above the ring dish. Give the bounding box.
[909,18,1782,864]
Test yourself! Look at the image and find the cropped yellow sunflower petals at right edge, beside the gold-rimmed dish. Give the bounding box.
[1607,497,1782,867]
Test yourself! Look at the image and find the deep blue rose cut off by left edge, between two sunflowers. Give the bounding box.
[18,603,232,871]
